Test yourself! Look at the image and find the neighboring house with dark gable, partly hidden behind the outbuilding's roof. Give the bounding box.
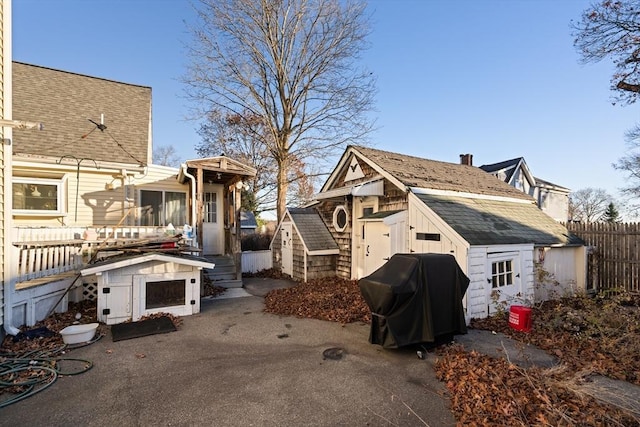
[480,158,571,222]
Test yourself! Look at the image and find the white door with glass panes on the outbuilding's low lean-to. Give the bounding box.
[487,252,525,314]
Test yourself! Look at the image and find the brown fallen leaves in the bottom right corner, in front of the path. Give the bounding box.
[435,344,637,426]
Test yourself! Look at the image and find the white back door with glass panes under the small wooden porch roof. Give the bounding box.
[202,184,224,255]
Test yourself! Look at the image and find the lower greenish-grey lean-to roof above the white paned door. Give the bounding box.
[416,193,584,246]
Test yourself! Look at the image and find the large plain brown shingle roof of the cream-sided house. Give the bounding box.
[13,61,151,165]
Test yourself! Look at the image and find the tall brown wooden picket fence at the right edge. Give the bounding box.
[566,222,640,291]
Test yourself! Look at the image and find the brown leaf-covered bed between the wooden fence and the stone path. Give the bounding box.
[471,293,640,385]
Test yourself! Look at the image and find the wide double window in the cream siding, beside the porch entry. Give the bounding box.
[140,190,187,226]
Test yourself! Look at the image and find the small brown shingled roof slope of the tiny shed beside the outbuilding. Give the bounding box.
[287,208,339,254]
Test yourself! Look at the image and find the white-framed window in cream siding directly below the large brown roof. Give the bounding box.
[12,177,65,215]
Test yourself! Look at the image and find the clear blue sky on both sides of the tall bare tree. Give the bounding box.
[12,0,640,210]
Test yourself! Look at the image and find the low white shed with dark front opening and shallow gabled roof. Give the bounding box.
[81,252,215,325]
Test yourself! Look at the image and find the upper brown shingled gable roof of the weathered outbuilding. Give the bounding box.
[340,146,534,203]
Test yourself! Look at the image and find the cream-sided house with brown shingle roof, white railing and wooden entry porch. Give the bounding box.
[3,62,255,333]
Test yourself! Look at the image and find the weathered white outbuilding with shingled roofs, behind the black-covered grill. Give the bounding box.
[272,146,586,319]
